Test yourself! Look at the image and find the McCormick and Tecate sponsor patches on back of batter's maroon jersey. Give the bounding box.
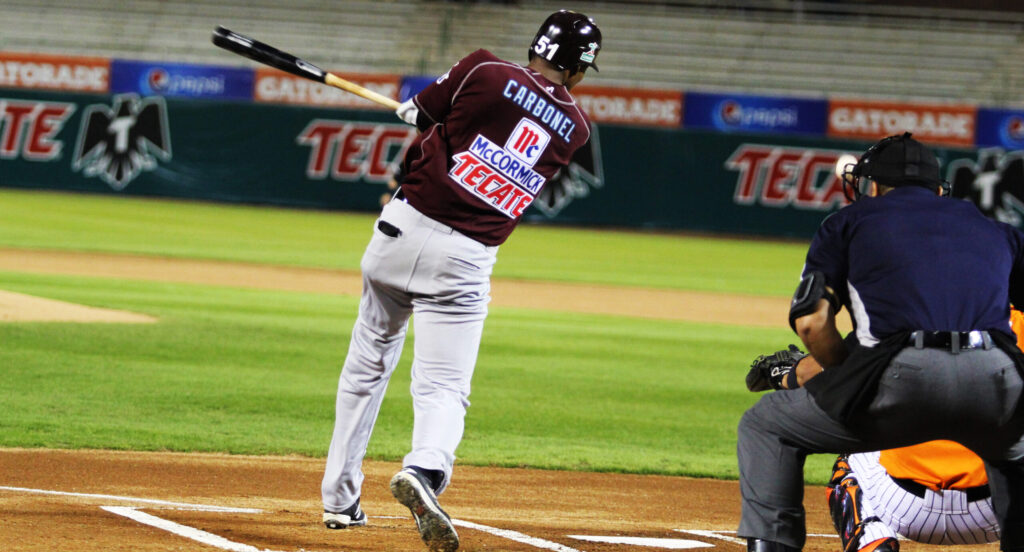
[449,133,550,218]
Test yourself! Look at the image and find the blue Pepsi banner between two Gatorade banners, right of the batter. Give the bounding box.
[683,92,828,135]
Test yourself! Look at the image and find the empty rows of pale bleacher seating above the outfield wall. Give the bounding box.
[0,0,1024,105]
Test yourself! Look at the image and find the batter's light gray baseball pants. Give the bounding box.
[321,200,498,511]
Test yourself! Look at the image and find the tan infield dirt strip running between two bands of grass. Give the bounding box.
[0,249,849,330]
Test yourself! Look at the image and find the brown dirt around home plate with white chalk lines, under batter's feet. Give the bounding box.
[0,449,997,552]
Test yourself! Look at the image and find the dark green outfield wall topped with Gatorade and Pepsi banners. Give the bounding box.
[0,52,1024,238]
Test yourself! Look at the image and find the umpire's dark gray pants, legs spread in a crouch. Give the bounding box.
[737,348,1024,550]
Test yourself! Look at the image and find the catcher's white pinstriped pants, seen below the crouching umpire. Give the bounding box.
[848,451,999,545]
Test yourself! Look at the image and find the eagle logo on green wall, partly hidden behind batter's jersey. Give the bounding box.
[534,125,604,218]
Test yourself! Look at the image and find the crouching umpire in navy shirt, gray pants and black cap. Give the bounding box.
[737,133,1024,552]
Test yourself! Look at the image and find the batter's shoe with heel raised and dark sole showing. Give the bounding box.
[391,467,459,552]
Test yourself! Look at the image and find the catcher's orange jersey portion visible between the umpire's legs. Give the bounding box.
[879,440,988,491]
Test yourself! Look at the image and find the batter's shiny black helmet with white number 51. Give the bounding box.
[529,9,601,74]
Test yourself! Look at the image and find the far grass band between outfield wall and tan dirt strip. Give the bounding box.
[0,189,806,297]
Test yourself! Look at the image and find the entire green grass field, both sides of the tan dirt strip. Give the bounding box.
[0,190,831,482]
